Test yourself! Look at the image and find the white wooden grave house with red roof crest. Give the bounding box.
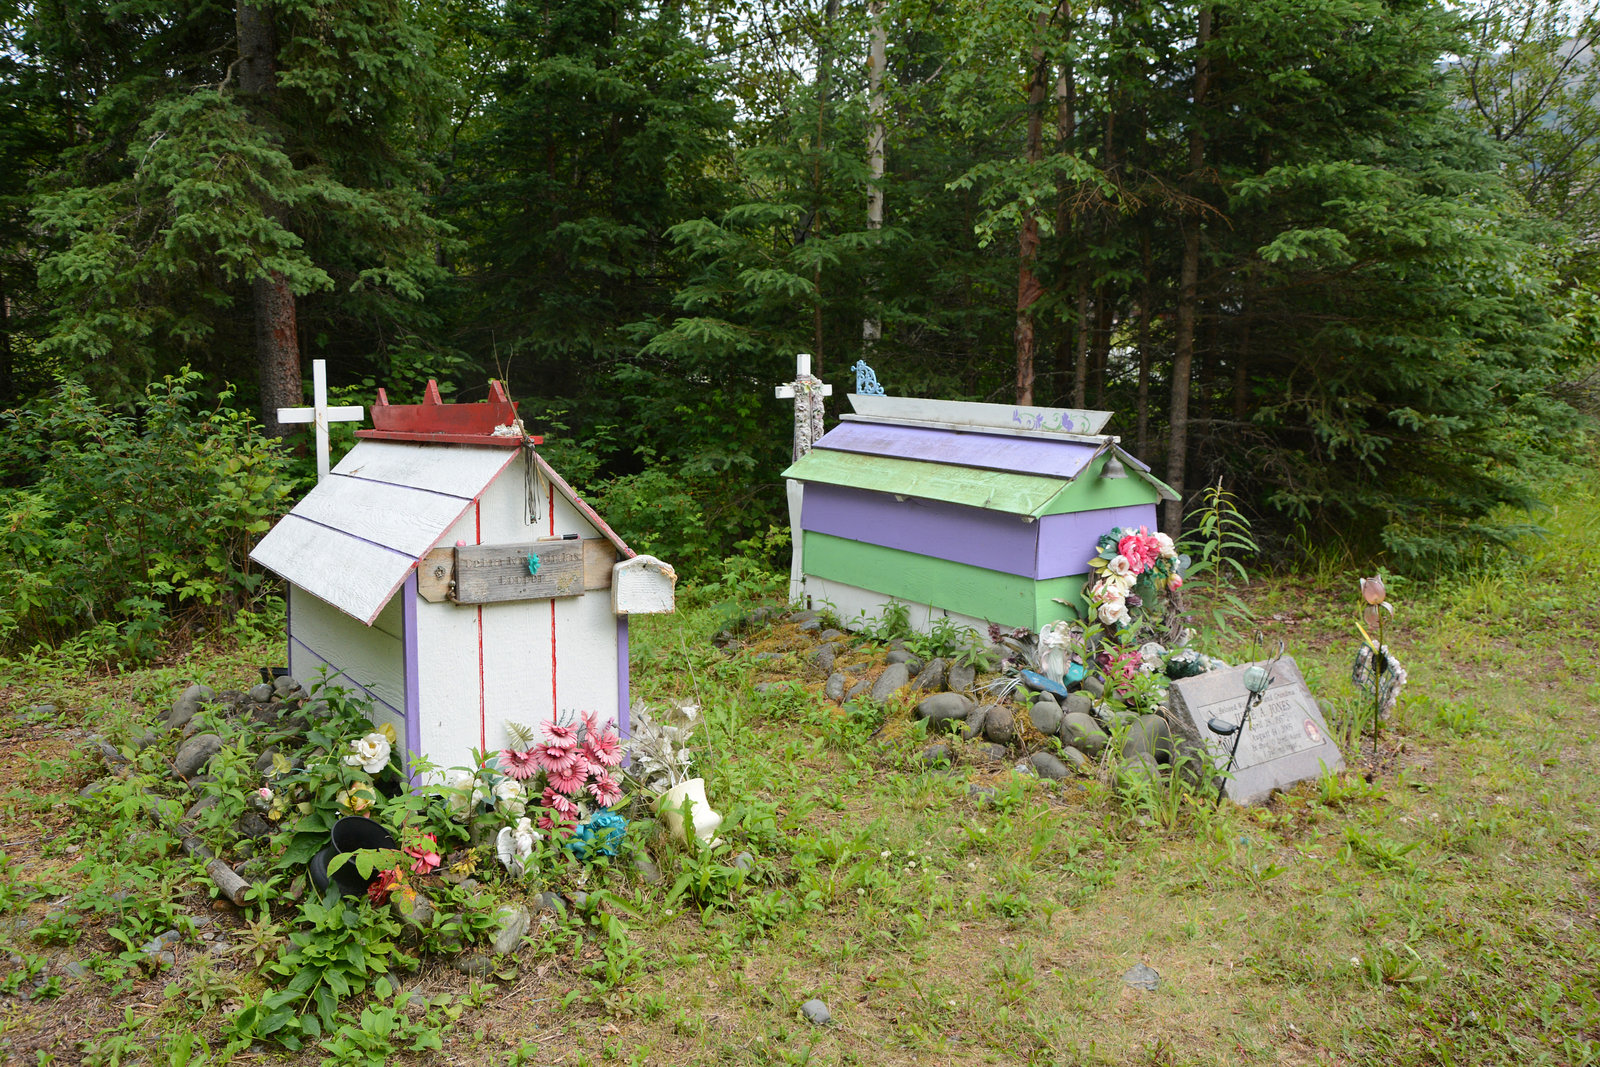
[250,382,677,768]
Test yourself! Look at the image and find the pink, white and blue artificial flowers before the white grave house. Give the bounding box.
[488,712,627,875]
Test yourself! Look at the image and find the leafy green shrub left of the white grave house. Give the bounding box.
[0,370,285,657]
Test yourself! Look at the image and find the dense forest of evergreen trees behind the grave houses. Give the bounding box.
[0,0,1600,651]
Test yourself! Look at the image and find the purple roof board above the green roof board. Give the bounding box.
[808,422,1098,479]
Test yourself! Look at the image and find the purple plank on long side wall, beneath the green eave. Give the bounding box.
[800,483,1036,577]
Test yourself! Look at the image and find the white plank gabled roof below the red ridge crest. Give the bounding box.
[250,440,634,625]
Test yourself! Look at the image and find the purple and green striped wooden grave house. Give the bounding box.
[784,392,1173,633]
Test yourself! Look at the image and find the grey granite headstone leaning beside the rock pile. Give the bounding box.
[1168,656,1344,805]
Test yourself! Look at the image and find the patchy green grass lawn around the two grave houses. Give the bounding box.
[0,460,1600,1067]
